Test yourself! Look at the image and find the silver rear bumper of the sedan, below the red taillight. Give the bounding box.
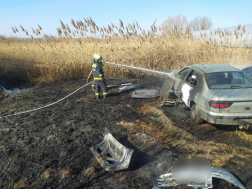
[200,110,252,125]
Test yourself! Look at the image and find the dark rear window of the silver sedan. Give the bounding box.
[205,72,252,89]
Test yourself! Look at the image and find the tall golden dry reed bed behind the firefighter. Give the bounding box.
[0,18,252,82]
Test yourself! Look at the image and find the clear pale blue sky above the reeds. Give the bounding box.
[0,0,252,37]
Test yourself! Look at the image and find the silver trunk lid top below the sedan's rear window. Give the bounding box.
[209,88,252,101]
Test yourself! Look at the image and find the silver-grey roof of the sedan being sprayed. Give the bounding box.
[190,64,241,73]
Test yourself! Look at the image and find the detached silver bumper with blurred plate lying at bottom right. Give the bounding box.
[152,159,246,189]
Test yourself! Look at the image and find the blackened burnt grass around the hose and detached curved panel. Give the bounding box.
[0,77,252,189]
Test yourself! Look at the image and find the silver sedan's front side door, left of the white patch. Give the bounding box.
[174,68,191,97]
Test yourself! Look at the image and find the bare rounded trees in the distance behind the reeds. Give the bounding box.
[161,15,213,33]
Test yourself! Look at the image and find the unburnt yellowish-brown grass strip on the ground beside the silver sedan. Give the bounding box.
[118,100,252,180]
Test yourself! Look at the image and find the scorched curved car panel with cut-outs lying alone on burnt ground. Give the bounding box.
[90,128,134,171]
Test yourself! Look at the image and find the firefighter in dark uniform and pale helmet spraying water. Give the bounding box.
[91,54,108,99]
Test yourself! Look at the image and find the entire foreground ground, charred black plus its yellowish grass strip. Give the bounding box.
[0,76,252,189]
